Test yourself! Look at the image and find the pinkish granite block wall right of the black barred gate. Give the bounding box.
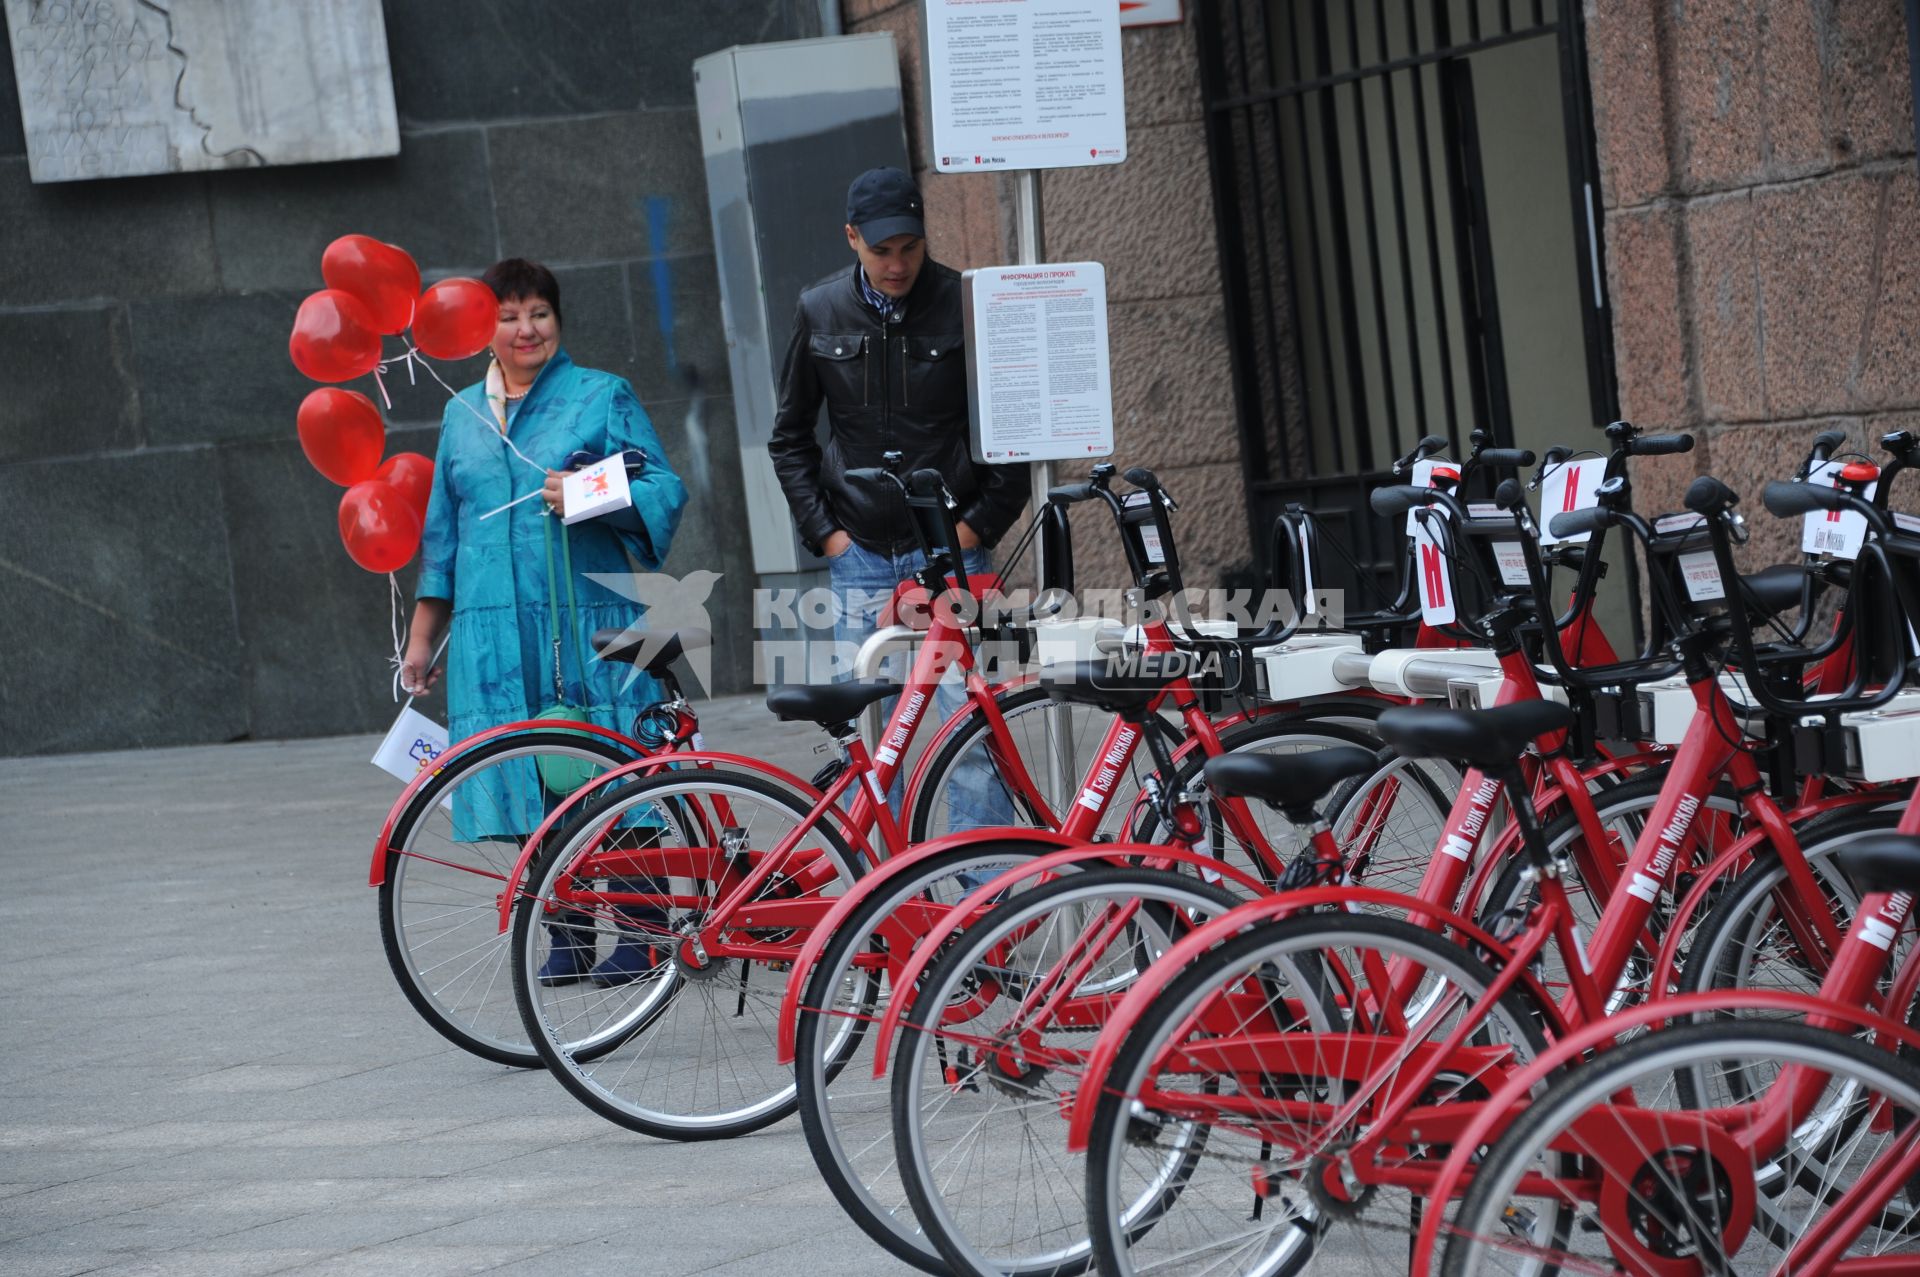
[1586,0,1920,563]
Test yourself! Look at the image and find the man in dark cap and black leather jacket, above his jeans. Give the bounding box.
[768,169,1029,559]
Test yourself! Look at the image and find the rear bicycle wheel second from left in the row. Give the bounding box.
[513,770,870,1141]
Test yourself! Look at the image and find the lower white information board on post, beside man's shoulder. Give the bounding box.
[962,261,1114,465]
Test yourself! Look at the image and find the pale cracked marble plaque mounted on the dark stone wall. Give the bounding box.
[4,0,399,182]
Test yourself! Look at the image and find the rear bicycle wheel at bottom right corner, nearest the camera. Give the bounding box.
[1442,1020,1920,1277]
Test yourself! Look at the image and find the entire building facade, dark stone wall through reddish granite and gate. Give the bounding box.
[0,0,1920,753]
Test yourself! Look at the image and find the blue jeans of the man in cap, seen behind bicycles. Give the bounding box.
[828,543,1014,833]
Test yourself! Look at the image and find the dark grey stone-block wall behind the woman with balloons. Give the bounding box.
[0,0,825,755]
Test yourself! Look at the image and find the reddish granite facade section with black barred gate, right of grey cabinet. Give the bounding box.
[843,0,1920,606]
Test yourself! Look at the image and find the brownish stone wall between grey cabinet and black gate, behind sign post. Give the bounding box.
[841,0,1252,586]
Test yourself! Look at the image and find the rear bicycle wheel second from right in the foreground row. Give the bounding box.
[1085,914,1544,1277]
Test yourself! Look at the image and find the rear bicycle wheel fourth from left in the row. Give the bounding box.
[893,868,1240,1277]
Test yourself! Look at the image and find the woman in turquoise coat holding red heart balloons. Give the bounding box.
[401,257,687,977]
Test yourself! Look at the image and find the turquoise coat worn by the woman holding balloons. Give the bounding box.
[419,349,687,839]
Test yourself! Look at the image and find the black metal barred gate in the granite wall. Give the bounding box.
[1196,0,1615,588]
